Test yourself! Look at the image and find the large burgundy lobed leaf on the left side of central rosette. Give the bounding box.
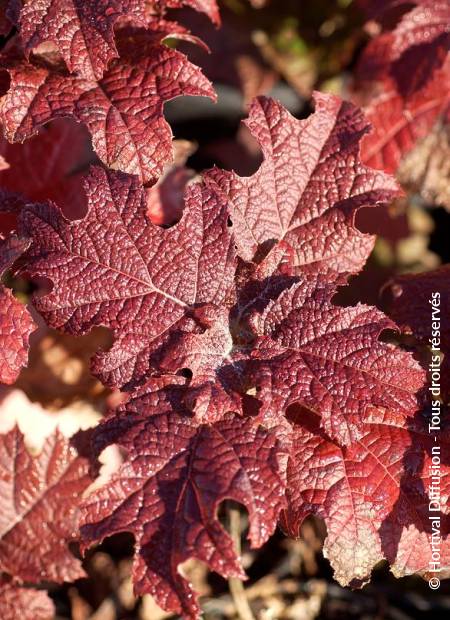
[23,168,234,385]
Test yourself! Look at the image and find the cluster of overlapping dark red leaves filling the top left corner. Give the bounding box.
[1,0,218,184]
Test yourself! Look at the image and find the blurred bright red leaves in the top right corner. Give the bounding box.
[356,0,450,173]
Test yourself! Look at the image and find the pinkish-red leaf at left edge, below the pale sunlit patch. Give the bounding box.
[0,428,91,583]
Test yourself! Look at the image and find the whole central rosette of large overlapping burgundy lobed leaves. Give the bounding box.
[18,95,442,617]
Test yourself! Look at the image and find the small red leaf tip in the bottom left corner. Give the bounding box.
[0,583,55,620]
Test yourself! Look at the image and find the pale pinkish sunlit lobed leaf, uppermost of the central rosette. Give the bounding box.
[206,94,397,273]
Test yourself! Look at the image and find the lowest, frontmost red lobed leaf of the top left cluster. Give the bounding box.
[2,29,215,184]
